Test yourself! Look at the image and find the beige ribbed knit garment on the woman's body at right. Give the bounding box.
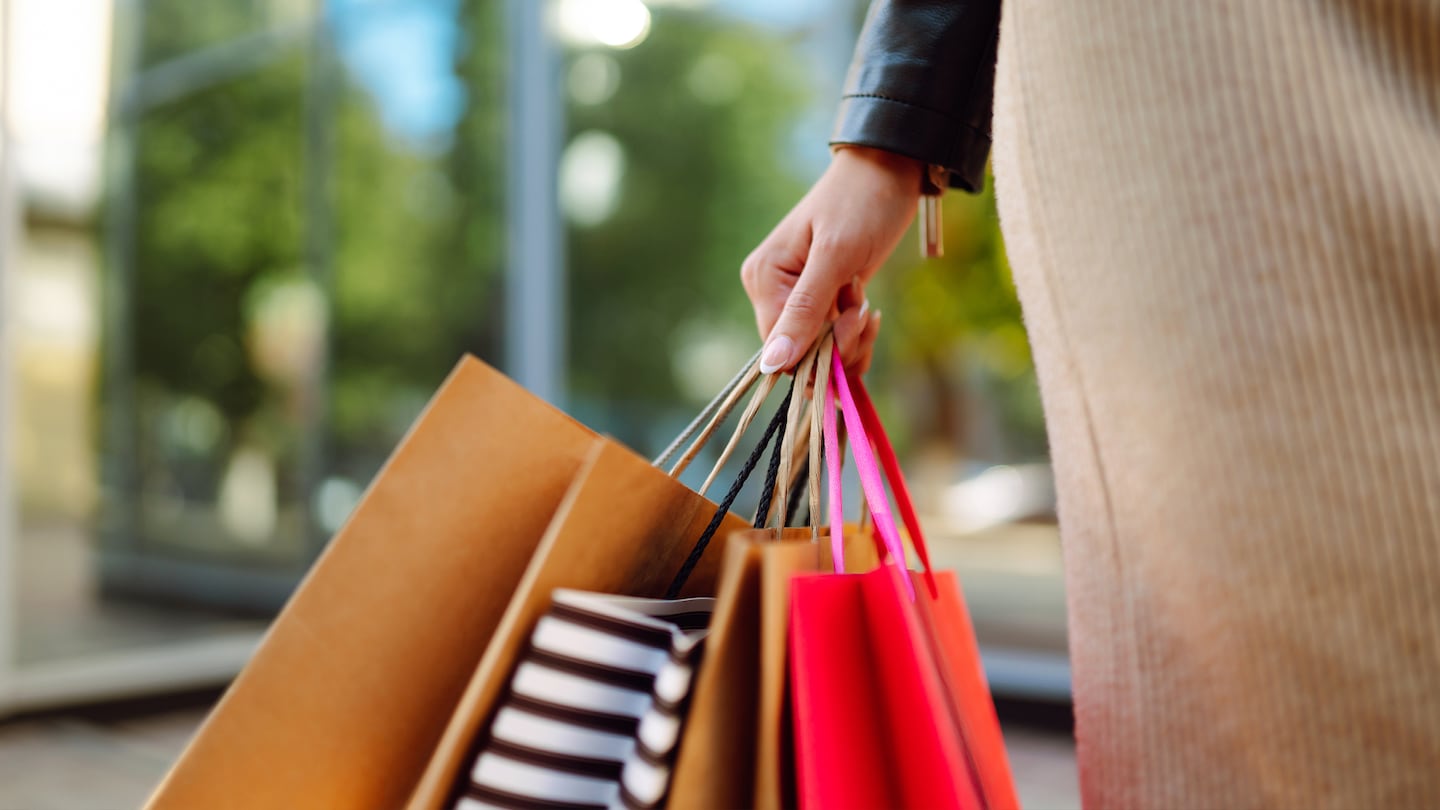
[994,0,1440,810]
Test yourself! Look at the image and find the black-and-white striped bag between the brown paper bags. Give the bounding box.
[456,589,714,810]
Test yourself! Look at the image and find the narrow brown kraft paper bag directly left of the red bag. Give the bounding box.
[670,526,877,810]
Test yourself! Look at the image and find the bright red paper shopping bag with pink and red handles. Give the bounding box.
[791,351,1018,810]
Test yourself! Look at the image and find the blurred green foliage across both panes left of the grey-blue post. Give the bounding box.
[124,0,475,510]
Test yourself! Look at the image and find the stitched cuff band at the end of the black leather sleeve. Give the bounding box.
[829,95,991,192]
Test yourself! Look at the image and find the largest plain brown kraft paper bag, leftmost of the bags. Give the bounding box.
[148,357,607,810]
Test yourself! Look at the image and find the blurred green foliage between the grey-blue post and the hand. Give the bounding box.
[558,10,809,402]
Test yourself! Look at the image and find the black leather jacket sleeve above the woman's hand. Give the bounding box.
[829,0,1001,192]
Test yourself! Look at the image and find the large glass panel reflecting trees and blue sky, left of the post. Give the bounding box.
[102,1,503,614]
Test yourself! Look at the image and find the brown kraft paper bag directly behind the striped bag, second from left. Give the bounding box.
[408,440,746,810]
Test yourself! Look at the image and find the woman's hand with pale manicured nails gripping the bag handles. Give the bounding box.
[740,147,922,373]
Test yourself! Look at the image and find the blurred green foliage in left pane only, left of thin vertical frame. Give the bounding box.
[131,0,304,497]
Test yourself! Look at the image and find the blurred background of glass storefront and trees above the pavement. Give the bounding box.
[0,0,1068,801]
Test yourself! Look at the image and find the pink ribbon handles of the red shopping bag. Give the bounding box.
[825,352,929,600]
